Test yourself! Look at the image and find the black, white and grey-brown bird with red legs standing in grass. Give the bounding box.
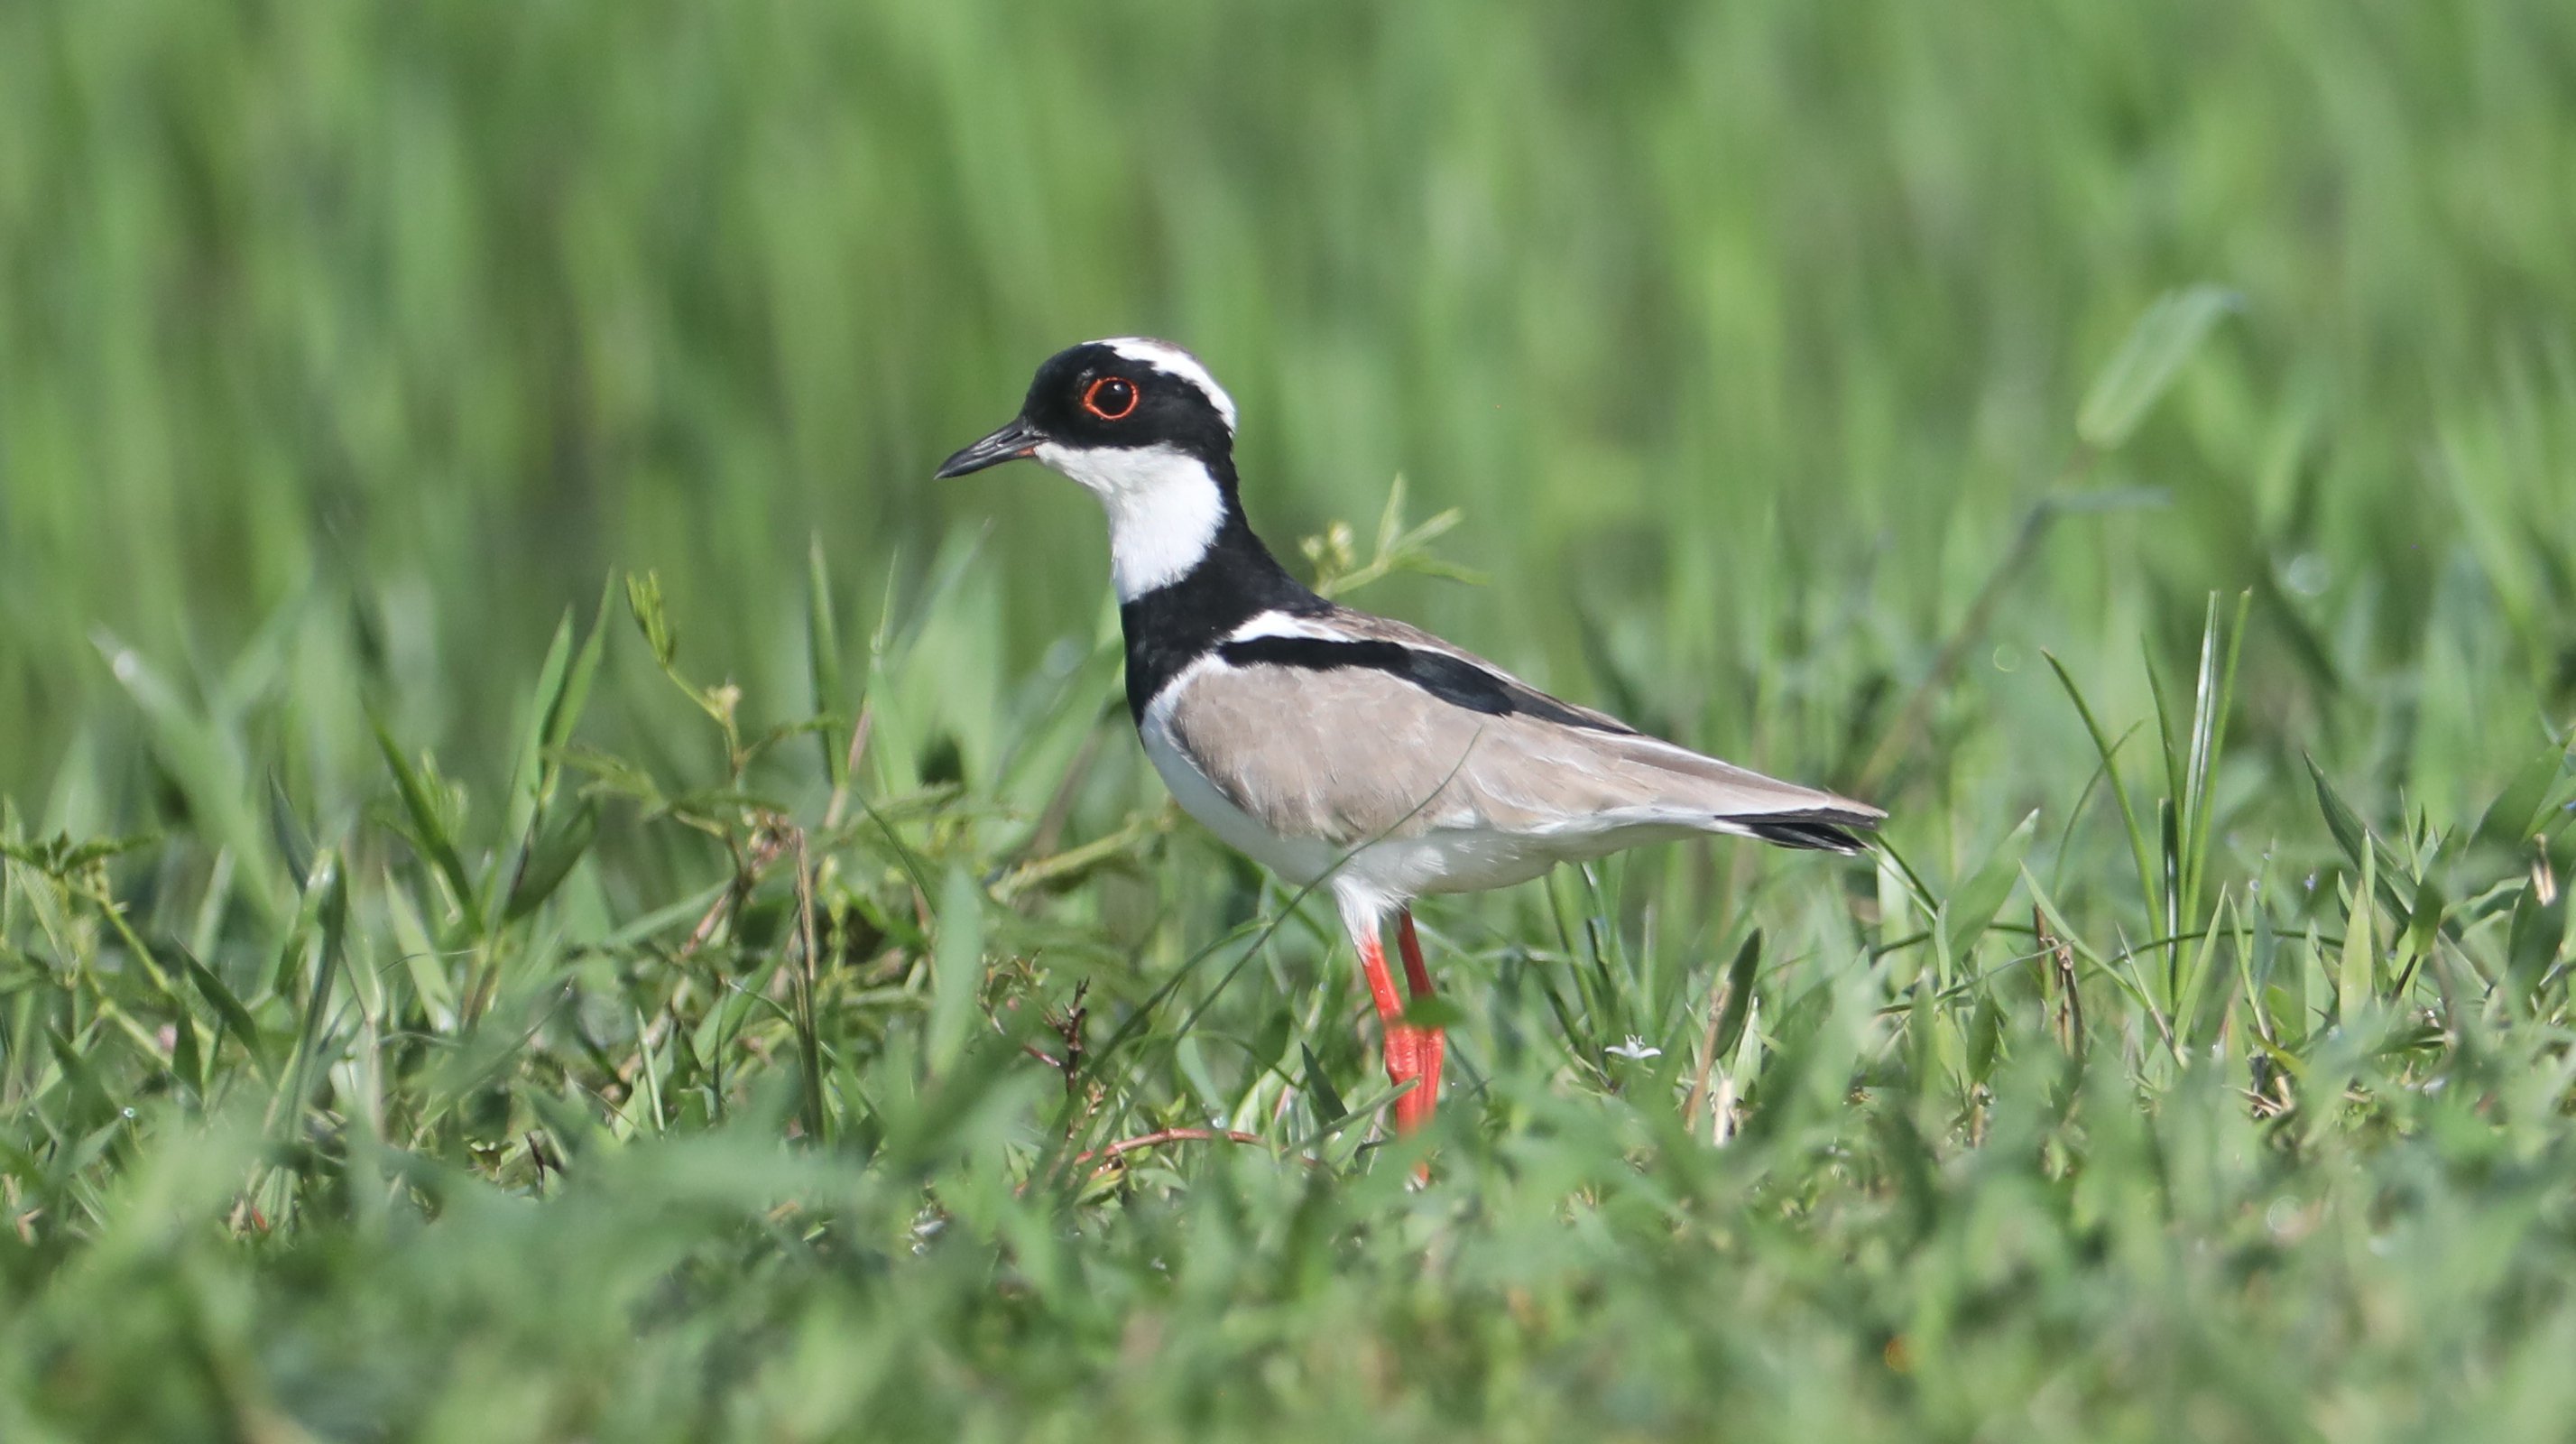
[937,335,1886,1137]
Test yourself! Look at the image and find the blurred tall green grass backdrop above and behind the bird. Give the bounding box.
[0,0,2576,815]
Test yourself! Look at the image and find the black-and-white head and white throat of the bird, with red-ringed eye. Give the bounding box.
[937,335,1234,598]
